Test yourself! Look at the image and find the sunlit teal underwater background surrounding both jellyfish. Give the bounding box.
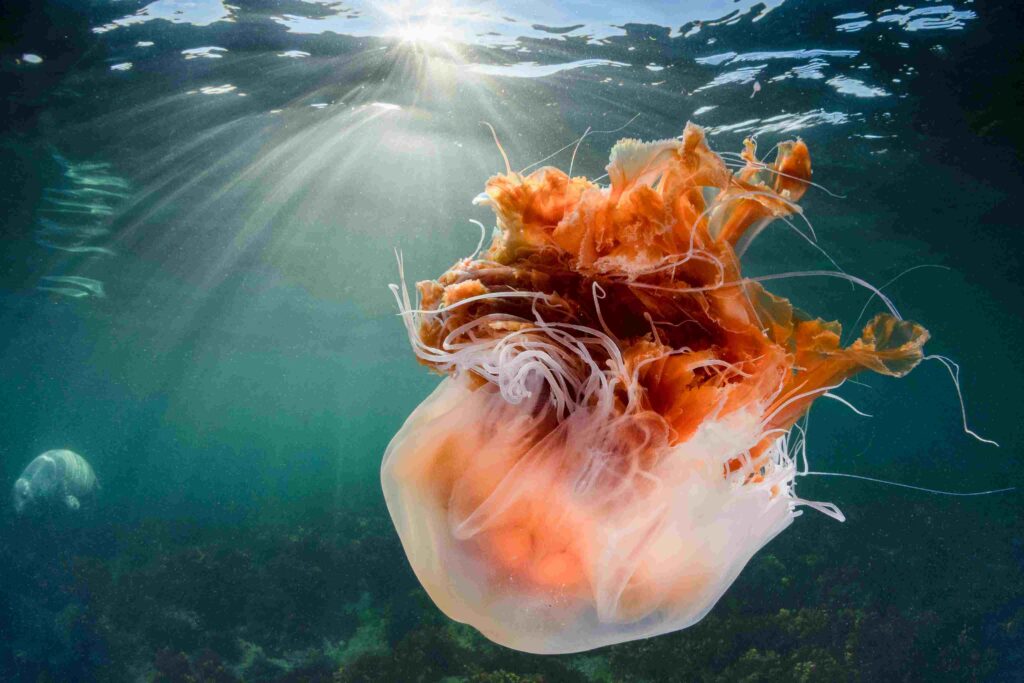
[0,0,1024,682]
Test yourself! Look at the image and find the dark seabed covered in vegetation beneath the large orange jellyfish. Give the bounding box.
[0,492,1024,683]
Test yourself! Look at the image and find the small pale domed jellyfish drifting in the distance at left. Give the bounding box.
[13,449,98,514]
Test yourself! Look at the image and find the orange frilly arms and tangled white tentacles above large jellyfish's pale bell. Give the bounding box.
[399,124,928,481]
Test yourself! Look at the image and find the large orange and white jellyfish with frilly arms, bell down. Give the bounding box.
[381,124,928,653]
